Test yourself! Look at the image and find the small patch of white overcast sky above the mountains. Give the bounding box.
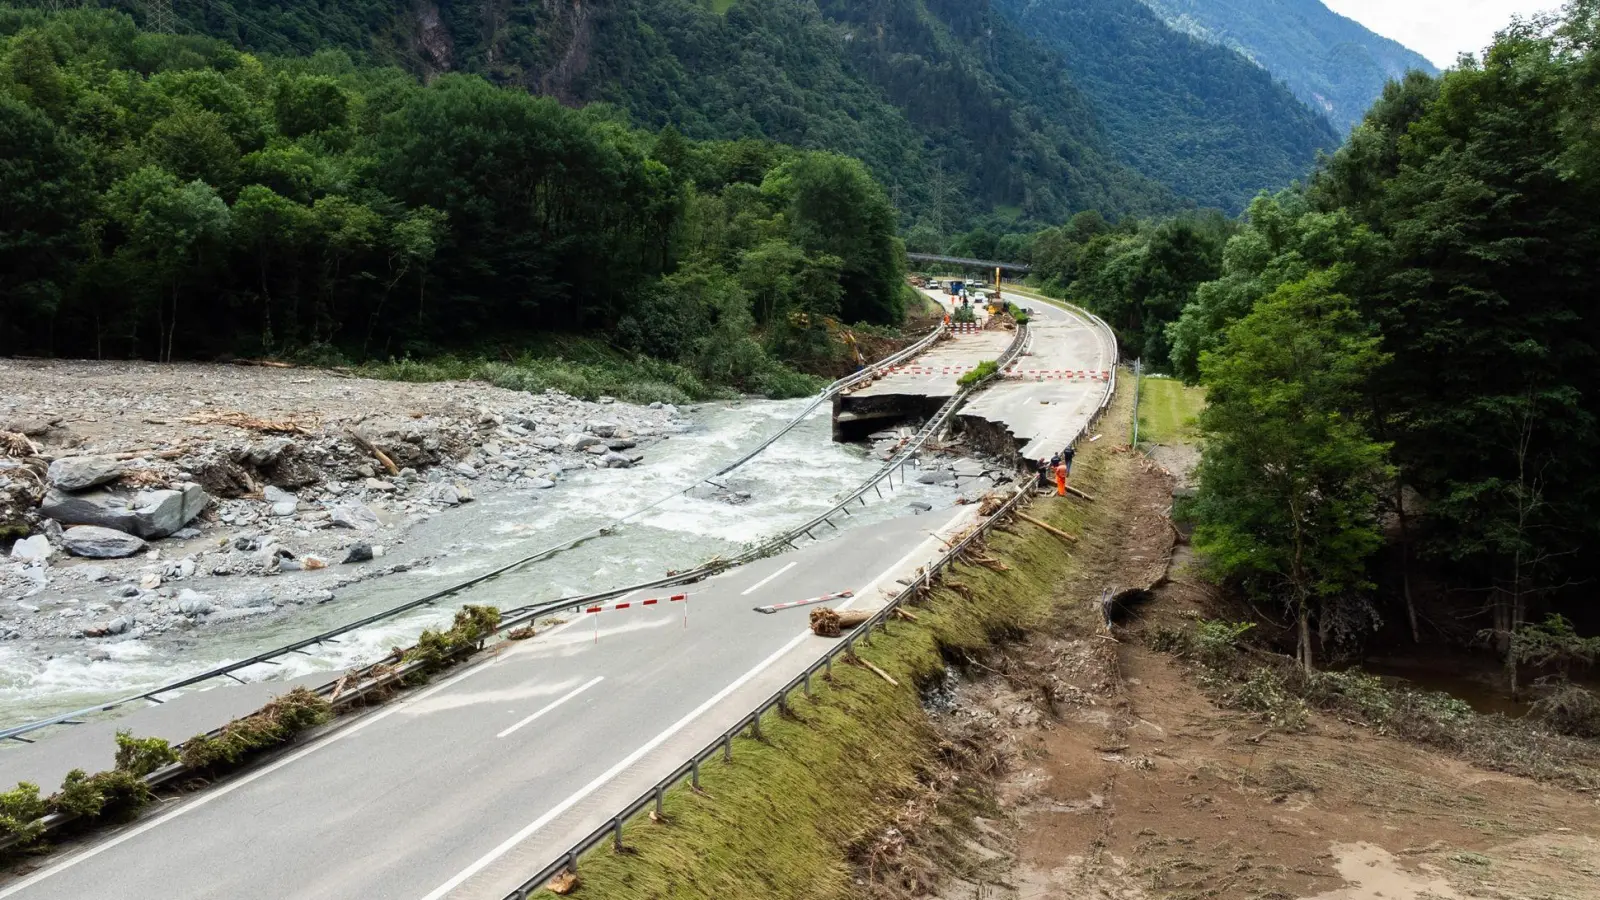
[1323,0,1562,69]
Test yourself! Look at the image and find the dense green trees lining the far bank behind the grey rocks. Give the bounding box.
[0,11,902,392]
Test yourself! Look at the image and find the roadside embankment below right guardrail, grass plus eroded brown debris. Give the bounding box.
[574,381,1126,900]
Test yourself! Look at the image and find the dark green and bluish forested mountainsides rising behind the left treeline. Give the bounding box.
[43,0,1336,219]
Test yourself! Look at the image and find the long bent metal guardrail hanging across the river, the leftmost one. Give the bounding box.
[0,325,946,743]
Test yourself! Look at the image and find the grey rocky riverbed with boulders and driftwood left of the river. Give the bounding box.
[0,360,688,643]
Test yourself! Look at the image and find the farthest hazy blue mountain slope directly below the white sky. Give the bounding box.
[1144,0,1438,138]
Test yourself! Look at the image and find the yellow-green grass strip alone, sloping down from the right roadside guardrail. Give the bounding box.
[563,402,1128,900]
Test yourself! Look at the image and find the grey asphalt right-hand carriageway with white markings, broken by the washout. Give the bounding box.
[0,288,1114,900]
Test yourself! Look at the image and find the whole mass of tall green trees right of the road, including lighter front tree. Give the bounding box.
[1062,0,1600,688]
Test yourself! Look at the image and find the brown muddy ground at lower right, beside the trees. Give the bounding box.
[902,395,1600,900]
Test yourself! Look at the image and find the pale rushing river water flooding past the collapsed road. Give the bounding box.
[0,399,955,724]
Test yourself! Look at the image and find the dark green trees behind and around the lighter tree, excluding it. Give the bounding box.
[1170,0,1600,679]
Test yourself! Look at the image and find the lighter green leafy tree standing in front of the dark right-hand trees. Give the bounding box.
[1194,272,1389,671]
